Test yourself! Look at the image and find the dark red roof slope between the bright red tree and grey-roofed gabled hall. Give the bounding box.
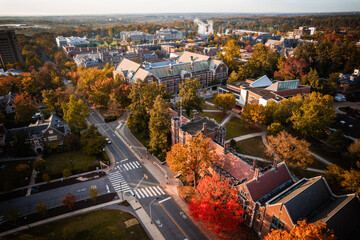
[246,163,291,202]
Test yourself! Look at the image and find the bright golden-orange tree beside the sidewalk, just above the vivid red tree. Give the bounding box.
[166,133,217,187]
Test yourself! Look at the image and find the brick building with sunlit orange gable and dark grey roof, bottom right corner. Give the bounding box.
[258,176,360,240]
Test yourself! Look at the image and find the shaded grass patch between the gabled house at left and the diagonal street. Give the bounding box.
[44,151,98,176]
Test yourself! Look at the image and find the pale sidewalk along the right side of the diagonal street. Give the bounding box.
[115,123,217,239]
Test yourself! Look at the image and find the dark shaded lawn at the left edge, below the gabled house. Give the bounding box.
[0,161,32,192]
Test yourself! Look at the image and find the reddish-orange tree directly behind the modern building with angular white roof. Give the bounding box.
[274,58,308,80]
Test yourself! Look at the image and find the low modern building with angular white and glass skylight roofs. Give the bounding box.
[218,75,310,107]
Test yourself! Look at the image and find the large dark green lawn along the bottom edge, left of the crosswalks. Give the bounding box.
[3,210,149,240]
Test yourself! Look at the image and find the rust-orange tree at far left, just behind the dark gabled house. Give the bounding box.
[14,92,37,123]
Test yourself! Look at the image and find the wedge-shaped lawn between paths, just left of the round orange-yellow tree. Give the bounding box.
[235,137,271,160]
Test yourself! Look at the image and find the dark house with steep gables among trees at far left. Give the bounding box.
[4,114,70,153]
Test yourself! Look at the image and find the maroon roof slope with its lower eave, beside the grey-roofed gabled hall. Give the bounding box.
[245,163,293,203]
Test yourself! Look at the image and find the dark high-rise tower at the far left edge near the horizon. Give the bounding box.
[0,30,24,68]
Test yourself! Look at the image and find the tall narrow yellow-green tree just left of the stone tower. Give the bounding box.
[149,95,170,160]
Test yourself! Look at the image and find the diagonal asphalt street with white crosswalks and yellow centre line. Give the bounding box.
[89,111,206,240]
